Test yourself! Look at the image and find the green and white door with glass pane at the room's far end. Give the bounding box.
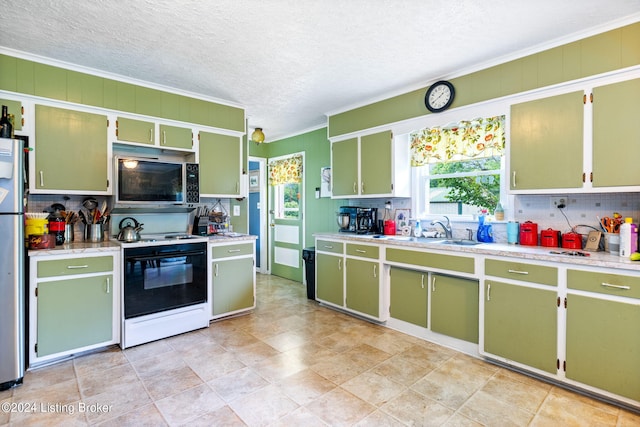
[269,153,304,282]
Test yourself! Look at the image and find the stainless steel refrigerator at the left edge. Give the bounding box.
[0,138,26,390]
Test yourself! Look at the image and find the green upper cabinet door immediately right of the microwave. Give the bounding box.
[199,132,242,197]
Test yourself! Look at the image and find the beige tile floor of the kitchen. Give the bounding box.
[0,275,640,427]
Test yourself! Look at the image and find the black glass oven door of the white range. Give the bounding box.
[123,243,207,319]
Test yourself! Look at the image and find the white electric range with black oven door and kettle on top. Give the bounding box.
[119,233,210,349]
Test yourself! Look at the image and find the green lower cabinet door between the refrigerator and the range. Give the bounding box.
[36,275,114,357]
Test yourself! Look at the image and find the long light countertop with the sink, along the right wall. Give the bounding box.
[314,233,640,271]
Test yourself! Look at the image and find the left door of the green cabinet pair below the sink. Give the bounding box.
[389,267,429,328]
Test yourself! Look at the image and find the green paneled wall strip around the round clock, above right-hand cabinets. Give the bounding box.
[329,23,640,137]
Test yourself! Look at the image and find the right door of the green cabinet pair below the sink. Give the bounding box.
[431,274,479,344]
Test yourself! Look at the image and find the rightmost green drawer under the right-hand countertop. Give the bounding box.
[567,270,640,298]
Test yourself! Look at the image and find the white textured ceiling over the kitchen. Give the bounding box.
[0,0,640,141]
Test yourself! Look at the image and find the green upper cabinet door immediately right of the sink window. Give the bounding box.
[509,91,584,193]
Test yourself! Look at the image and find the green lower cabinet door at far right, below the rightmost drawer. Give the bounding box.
[566,295,640,401]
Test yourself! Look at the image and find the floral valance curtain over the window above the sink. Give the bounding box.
[409,115,505,166]
